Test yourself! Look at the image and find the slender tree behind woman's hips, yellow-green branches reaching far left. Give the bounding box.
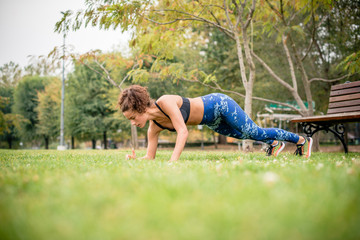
[56,0,256,150]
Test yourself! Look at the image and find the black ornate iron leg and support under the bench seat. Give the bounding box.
[301,122,348,153]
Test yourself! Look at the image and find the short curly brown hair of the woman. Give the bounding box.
[118,85,153,113]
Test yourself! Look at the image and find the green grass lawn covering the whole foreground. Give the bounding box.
[0,150,360,240]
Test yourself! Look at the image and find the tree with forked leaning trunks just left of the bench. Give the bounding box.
[252,0,359,151]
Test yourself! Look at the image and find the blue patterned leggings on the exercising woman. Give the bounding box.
[200,93,299,144]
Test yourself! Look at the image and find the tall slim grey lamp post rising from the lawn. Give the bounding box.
[57,12,66,150]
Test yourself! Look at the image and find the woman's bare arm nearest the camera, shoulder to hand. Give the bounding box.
[158,95,188,162]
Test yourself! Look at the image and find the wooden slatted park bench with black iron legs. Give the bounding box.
[291,81,360,153]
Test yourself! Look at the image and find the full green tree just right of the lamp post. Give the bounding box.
[65,63,117,149]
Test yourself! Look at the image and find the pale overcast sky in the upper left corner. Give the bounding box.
[0,0,130,67]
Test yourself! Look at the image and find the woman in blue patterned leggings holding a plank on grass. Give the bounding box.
[118,85,313,161]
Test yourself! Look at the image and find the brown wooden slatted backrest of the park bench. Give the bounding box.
[327,81,360,114]
